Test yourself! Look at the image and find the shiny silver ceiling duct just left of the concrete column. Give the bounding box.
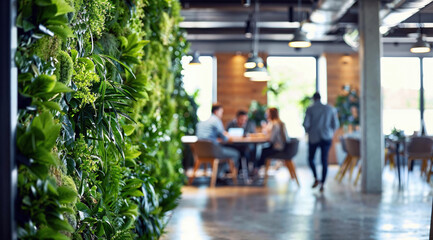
[302,0,356,39]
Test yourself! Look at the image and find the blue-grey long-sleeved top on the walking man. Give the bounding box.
[303,101,340,143]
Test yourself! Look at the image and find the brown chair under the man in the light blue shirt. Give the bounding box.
[188,140,237,187]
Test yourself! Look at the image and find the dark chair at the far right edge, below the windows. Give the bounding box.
[406,136,433,181]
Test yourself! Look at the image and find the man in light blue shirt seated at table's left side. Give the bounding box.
[196,103,239,178]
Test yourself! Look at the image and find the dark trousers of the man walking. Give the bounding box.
[308,140,332,183]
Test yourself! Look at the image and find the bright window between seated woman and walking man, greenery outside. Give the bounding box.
[267,57,316,138]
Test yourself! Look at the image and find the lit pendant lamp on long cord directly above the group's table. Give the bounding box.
[244,0,269,81]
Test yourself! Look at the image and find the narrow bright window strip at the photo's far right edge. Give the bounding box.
[423,58,433,135]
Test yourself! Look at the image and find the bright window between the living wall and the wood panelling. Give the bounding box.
[182,56,215,121]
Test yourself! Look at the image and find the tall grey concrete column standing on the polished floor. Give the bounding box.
[358,0,384,193]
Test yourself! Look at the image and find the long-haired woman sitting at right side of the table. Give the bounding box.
[254,108,288,175]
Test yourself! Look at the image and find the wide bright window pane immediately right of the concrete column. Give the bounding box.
[381,57,421,134]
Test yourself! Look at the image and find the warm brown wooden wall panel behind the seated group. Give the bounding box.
[215,53,267,126]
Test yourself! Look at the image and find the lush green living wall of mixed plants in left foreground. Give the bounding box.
[15,0,195,239]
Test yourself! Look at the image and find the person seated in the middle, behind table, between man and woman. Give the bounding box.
[226,110,256,169]
